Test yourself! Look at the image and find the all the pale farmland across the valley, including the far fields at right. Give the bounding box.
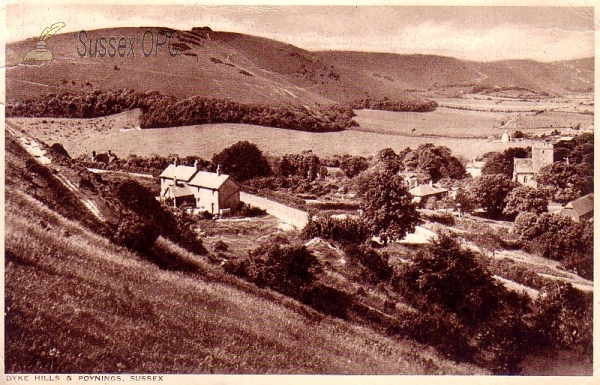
[11,94,594,158]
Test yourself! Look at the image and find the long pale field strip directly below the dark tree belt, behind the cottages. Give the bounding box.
[10,113,531,159]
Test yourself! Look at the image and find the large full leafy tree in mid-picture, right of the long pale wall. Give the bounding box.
[359,172,419,243]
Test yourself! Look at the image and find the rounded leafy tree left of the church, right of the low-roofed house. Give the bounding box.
[471,174,518,218]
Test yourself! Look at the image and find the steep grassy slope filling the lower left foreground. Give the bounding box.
[5,134,481,374]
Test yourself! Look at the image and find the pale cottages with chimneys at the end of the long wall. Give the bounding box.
[159,161,240,215]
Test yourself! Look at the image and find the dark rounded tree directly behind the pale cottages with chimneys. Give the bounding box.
[212,141,271,182]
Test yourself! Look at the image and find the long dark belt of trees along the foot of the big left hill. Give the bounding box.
[6,89,358,132]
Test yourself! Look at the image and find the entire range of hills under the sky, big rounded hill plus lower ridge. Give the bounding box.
[6,27,594,106]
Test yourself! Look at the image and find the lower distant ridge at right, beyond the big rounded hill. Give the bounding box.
[319,51,594,95]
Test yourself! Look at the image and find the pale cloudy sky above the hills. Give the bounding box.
[6,0,598,61]
